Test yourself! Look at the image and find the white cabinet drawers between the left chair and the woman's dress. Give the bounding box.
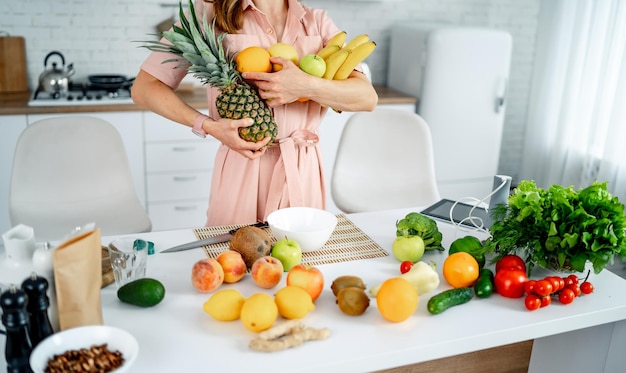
[143,112,219,231]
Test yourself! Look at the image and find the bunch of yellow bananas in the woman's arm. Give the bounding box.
[317,31,376,80]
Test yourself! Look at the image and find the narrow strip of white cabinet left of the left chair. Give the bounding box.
[0,115,26,235]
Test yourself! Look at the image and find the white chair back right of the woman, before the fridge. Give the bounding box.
[331,109,440,213]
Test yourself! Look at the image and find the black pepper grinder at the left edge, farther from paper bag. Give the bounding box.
[0,285,32,373]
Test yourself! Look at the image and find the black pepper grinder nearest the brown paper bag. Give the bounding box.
[22,272,54,348]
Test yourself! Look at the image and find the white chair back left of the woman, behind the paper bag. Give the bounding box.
[9,116,152,241]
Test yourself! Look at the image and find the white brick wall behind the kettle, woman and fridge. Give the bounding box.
[0,0,540,179]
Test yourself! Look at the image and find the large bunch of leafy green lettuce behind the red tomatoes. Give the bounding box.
[485,180,626,273]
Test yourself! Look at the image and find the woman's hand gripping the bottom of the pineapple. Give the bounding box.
[210,118,271,159]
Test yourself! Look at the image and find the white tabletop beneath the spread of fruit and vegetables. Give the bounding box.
[0,208,626,372]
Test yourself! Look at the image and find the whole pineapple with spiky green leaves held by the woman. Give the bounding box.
[143,0,278,142]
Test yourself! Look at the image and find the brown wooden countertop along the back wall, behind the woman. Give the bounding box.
[0,86,417,115]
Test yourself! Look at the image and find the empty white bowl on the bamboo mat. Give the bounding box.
[267,207,337,252]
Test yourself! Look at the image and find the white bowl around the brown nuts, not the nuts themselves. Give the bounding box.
[30,325,139,373]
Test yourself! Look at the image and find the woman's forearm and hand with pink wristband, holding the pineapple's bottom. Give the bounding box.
[131,70,270,159]
